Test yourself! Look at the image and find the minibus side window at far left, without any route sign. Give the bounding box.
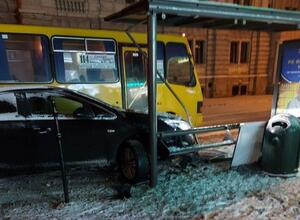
[0,33,52,83]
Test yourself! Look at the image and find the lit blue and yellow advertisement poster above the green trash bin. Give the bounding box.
[276,41,300,117]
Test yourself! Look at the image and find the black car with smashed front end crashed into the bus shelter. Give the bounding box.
[0,87,194,180]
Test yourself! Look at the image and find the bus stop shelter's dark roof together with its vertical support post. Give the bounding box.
[105,0,300,186]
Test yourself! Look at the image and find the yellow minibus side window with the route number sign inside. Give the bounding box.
[53,37,118,83]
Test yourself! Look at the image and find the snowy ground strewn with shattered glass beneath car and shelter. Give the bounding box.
[0,158,286,219]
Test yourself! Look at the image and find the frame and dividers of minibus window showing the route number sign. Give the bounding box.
[50,35,121,85]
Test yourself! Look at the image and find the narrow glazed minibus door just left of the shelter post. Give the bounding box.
[122,47,148,112]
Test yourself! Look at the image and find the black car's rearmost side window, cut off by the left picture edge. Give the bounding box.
[0,93,18,120]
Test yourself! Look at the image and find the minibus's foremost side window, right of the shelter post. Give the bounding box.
[166,43,194,85]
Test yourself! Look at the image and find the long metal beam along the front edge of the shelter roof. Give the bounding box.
[148,0,300,24]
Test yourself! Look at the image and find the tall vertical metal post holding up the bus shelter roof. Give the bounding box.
[147,11,157,187]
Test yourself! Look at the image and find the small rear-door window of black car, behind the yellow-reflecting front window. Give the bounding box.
[26,93,53,117]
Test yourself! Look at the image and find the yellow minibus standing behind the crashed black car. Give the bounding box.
[0,24,203,126]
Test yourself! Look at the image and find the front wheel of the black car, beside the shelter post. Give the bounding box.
[119,140,149,182]
